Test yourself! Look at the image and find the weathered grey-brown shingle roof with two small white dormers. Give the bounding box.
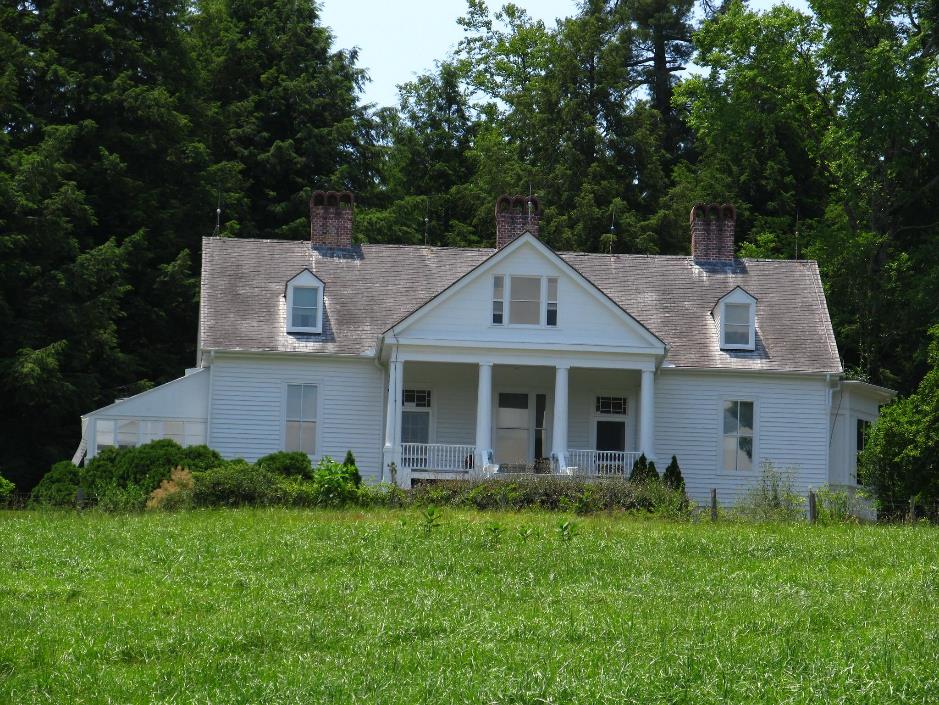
[199,238,841,372]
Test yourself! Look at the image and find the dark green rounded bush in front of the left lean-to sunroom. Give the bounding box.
[80,439,224,500]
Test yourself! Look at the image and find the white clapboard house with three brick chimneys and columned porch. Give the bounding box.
[79,192,893,501]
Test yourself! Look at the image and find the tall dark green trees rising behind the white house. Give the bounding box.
[0,0,939,489]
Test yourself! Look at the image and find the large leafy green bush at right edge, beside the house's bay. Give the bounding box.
[858,325,939,516]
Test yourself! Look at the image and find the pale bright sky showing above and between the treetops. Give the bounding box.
[321,0,807,106]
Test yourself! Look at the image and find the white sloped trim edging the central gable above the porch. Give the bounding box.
[384,231,665,352]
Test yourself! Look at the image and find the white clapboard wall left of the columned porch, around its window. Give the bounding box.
[209,355,385,481]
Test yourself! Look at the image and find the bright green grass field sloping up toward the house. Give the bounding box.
[0,510,939,704]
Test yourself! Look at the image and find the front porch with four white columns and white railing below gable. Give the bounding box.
[385,360,655,486]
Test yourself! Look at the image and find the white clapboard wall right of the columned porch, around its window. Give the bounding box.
[655,368,828,504]
